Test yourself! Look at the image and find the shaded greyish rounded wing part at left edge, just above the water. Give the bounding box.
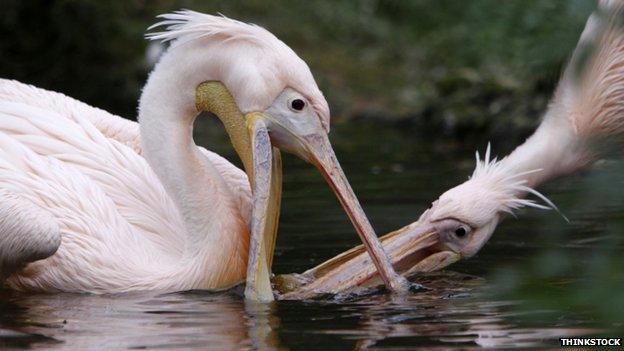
[0,190,61,279]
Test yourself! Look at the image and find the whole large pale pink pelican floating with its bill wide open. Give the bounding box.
[0,11,405,301]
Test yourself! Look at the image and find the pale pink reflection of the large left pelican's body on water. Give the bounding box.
[2,292,277,350]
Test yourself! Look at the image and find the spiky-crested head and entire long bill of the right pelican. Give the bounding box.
[276,146,556,299]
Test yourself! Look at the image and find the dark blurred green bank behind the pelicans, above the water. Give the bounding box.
[0,0,595,132]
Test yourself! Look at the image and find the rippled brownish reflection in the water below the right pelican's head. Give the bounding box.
[348,274,592,350]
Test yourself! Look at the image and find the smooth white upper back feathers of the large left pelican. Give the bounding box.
[0,80,188,250]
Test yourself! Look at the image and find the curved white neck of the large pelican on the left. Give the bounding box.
[139,51,248,287]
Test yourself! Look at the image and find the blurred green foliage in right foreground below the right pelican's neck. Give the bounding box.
[492,162,624,334]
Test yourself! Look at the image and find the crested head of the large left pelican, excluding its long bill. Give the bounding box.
[148,10,330,151]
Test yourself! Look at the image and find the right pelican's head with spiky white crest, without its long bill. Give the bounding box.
[394,145,556,271]
